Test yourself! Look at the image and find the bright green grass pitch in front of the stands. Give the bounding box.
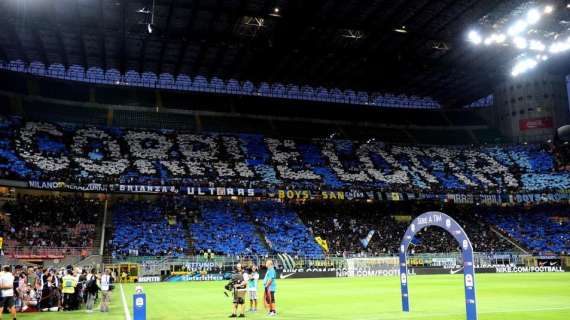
[13,273,570,320]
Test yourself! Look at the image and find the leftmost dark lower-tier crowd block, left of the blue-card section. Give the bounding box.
[0,195,103,249]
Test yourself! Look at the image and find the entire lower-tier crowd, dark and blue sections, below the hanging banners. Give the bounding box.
[0,194,570,258]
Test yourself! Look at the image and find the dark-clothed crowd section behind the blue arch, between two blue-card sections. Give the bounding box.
[296,201,516,256]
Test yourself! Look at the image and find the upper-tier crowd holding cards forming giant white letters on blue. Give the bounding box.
[0,118,570,193]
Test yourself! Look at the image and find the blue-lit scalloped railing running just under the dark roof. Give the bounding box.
[0,60,441,109]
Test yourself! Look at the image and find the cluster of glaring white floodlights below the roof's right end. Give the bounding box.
[467,5,570,77]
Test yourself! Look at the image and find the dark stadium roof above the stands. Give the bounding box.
[0,0,568,106]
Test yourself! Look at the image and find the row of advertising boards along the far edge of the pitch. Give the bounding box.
[101,253,570,282]
